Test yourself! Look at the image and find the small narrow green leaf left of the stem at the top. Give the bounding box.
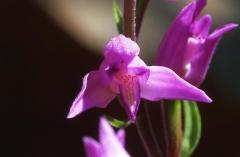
[112,0,123,34]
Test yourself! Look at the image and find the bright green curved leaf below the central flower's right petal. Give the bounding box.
[181,101,202,157]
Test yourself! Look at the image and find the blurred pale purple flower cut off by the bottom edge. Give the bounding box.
[83,118,130,157]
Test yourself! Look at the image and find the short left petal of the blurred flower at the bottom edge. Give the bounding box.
[83,137,102,157]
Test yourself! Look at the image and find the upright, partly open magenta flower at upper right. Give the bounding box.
[157,0,238,86]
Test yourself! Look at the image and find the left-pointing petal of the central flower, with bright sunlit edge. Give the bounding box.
[67,71,116,118]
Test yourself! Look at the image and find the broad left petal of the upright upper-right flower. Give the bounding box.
[157,2,196,73]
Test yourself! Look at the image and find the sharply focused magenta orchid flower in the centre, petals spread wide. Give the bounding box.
[68,35,211,122]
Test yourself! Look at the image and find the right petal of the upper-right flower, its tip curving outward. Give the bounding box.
[186,24,238,86]
